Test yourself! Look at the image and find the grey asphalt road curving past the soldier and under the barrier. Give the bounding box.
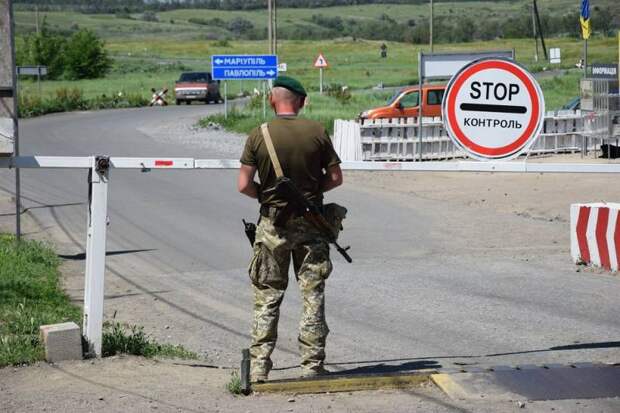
[0,106,620,375]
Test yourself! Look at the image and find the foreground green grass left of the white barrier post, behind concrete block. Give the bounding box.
[0,234,81,367]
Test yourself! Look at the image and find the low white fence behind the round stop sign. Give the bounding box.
[334,111,610,161]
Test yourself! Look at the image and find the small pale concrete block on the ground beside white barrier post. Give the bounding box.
[39,322,82,363]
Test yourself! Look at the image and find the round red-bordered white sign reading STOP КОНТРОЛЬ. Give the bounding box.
[442,58,545,160]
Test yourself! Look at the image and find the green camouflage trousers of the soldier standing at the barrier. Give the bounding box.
[249,217,332,374]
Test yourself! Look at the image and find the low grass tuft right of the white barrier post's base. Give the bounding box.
[101,322,198,360]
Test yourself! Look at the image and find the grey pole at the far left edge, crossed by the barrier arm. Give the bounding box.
[0,0,21,241]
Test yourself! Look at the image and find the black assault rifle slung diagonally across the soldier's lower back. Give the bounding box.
[268,177,353,263]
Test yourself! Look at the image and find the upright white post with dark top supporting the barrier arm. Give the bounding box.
[83,156,110,357]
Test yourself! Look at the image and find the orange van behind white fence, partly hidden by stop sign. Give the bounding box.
[360,85,446,119]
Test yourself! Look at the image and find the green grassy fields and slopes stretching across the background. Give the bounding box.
[16,0,618,111]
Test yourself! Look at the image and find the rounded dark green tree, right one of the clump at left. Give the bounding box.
[65,29,112,80]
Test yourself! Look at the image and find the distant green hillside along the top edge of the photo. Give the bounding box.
[16,0,620,44]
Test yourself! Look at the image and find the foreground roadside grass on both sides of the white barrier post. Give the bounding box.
[0,234,198,367]
